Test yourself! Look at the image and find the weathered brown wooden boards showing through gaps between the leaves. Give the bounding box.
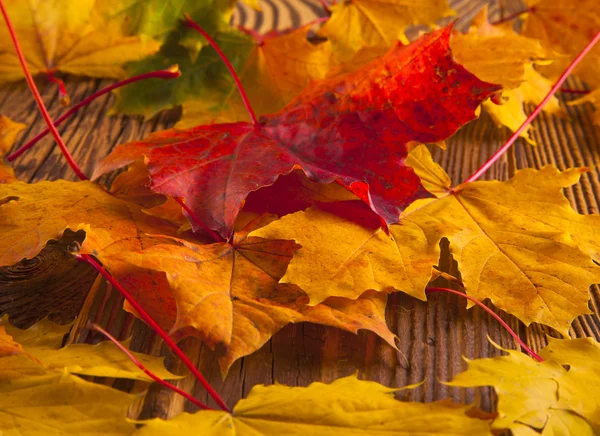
[0,0,600,417]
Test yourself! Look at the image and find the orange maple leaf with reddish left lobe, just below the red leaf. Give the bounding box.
[105,217,395,373]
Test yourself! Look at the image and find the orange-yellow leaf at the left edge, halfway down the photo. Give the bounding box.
[0,180,176,266]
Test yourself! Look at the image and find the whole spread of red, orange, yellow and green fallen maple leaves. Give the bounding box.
[0,0,600,435]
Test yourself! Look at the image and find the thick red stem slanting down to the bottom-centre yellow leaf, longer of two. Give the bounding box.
[76,254,230,412]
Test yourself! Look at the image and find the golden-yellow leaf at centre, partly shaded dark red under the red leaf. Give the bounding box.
[251,201,438,304]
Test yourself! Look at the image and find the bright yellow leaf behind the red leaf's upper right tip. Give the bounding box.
[450,7,561,144]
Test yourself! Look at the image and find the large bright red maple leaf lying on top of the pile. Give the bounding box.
[93,27,497,237]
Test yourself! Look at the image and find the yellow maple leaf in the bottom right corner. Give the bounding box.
[447,338,600,435]
